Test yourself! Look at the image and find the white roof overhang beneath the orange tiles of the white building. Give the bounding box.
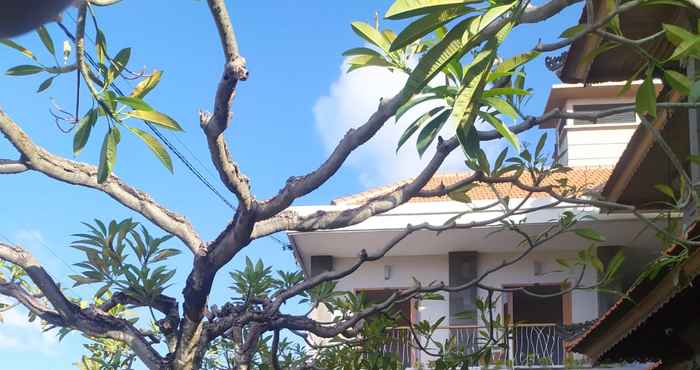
[289,198,655,267]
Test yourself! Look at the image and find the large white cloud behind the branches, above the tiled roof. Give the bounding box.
[313,66,504,186]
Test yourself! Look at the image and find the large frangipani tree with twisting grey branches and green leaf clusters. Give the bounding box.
[0,0,698,370]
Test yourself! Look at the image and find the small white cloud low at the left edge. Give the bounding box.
[0,307,58,355]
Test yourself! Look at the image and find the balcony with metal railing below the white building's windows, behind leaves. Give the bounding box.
[385,324,566,370]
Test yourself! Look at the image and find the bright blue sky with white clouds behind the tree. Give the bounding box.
[0,0,579,369]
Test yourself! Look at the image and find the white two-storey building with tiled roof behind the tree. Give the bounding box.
[289,84,658,368]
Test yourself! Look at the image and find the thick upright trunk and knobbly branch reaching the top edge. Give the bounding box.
[175,0,255,369]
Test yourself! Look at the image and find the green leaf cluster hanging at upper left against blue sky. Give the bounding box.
[0,18,182,183]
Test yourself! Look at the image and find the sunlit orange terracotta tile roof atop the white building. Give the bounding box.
[331,167,612,205]
